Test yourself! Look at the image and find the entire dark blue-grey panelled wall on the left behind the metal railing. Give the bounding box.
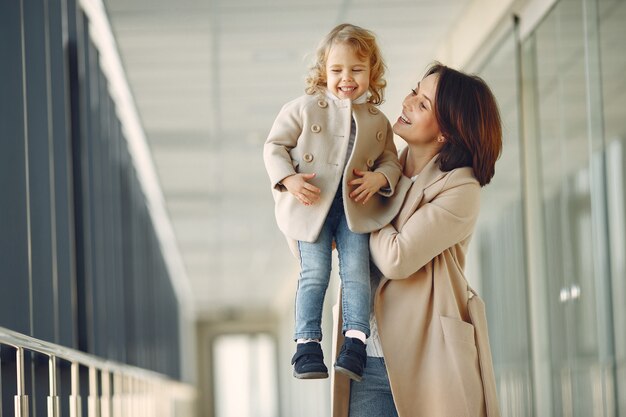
[0,0,179,404]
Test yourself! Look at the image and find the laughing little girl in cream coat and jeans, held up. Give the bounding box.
[263,24,401,381]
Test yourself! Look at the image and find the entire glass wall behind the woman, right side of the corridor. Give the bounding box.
[475,0,626,417]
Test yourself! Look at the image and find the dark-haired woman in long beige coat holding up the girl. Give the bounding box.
[333,63,502,417]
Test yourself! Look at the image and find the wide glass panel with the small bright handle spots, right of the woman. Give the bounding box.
[527,0,612,417]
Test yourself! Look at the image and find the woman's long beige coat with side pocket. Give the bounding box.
[333,150,499,417]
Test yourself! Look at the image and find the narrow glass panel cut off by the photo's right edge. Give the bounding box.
[598,0,626,410]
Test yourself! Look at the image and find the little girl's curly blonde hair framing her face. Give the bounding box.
[304,23,387,105]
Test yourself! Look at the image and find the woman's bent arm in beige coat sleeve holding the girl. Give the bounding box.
[370,172,480,279]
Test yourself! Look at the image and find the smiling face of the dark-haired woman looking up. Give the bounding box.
[393,74,441,145]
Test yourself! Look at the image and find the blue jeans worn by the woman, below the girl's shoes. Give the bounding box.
[348,356,398,417]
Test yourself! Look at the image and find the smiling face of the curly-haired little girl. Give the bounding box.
[326,42,371,100]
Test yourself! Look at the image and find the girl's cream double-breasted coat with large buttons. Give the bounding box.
[263,95,401,242]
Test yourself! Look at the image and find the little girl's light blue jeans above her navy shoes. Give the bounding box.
[294,187,370,340]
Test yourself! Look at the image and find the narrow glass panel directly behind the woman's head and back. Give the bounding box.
[470,27,533,416]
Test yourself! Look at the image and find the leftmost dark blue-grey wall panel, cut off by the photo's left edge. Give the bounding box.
[0,1,30,334]
